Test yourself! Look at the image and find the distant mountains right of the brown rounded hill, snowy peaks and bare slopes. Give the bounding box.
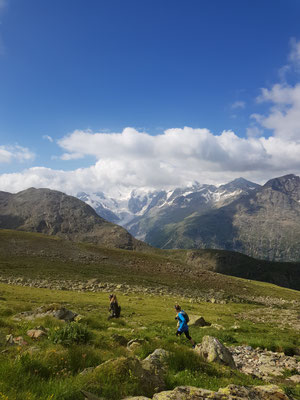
[78,175,300,261]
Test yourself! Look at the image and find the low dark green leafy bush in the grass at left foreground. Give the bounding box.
[49,322,91,346]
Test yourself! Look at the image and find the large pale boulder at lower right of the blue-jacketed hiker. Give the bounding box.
[195,336,236,368]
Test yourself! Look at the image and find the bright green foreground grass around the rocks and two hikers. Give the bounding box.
[0,284,300,400]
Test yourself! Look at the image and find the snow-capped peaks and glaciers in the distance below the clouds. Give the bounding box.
[77,178,259,240]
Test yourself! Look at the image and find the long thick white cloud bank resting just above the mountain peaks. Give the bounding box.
[0,127,300,196]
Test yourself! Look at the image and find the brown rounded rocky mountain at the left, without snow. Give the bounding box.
[0,188,147,250]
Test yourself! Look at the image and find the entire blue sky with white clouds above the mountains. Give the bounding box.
[0,0,300,196]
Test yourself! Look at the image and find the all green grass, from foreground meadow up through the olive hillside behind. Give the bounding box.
[0,230,300,400]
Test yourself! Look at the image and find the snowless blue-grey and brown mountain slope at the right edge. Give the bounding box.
[146,175,300,261]
